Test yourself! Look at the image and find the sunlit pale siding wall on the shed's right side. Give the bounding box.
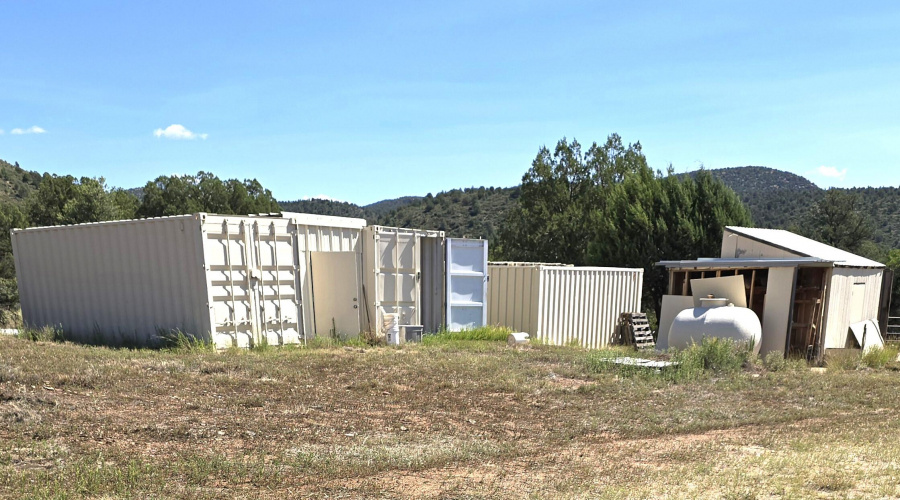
[825,267,884,349]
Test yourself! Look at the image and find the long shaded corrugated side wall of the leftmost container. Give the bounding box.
[12,215,210,345]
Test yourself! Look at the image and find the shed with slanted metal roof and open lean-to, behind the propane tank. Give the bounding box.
[659,226,890,359]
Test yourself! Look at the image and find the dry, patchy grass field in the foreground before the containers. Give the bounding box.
[0,330,900,499]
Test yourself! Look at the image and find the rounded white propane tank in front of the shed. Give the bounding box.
[669,298,762,354]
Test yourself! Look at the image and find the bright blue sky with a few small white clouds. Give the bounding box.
[0,0,900,204]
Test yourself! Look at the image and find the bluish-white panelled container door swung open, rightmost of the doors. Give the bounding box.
[447,238,488,331]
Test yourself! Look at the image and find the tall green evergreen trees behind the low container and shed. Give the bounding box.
[495,134,751,313]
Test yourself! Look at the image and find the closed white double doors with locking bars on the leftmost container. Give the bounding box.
[204,217,302,347]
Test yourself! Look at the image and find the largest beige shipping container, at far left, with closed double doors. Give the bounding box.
[12,213,365,347]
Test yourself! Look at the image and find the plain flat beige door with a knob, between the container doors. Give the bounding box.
[309,252,360,338]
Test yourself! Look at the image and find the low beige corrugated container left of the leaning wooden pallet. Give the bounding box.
[488,262,644,348]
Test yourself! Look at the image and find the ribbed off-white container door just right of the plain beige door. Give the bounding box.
[375,229,421,328]
